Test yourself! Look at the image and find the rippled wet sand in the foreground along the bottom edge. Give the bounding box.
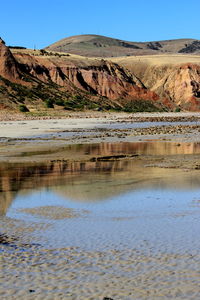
[0,248,200,300]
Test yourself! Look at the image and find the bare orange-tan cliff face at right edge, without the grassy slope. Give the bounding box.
[143,64,200,110]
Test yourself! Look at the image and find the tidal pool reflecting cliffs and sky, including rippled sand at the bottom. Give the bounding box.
[0,142,200,300]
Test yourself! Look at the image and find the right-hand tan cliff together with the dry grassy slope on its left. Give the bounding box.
[115,58,200,111]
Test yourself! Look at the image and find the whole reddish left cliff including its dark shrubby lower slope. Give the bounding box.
[0,42,160,109]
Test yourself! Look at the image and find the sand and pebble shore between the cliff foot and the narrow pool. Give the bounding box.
[0,113,200,168]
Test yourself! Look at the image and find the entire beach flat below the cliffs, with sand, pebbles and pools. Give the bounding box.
[0,113,200,300]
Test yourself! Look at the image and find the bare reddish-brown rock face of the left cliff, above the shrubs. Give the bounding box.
[0,41,159,107]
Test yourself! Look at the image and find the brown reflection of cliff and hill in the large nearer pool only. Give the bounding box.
[0,160,200,215]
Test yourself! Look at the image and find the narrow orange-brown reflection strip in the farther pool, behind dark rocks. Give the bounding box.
[14,141,200,160]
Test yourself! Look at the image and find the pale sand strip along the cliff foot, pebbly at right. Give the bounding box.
[0,112,200,139]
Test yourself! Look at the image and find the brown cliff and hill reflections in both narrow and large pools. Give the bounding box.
[0,142,200,215]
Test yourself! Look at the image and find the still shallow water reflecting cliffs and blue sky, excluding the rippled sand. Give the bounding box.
[0,142,200,254]
